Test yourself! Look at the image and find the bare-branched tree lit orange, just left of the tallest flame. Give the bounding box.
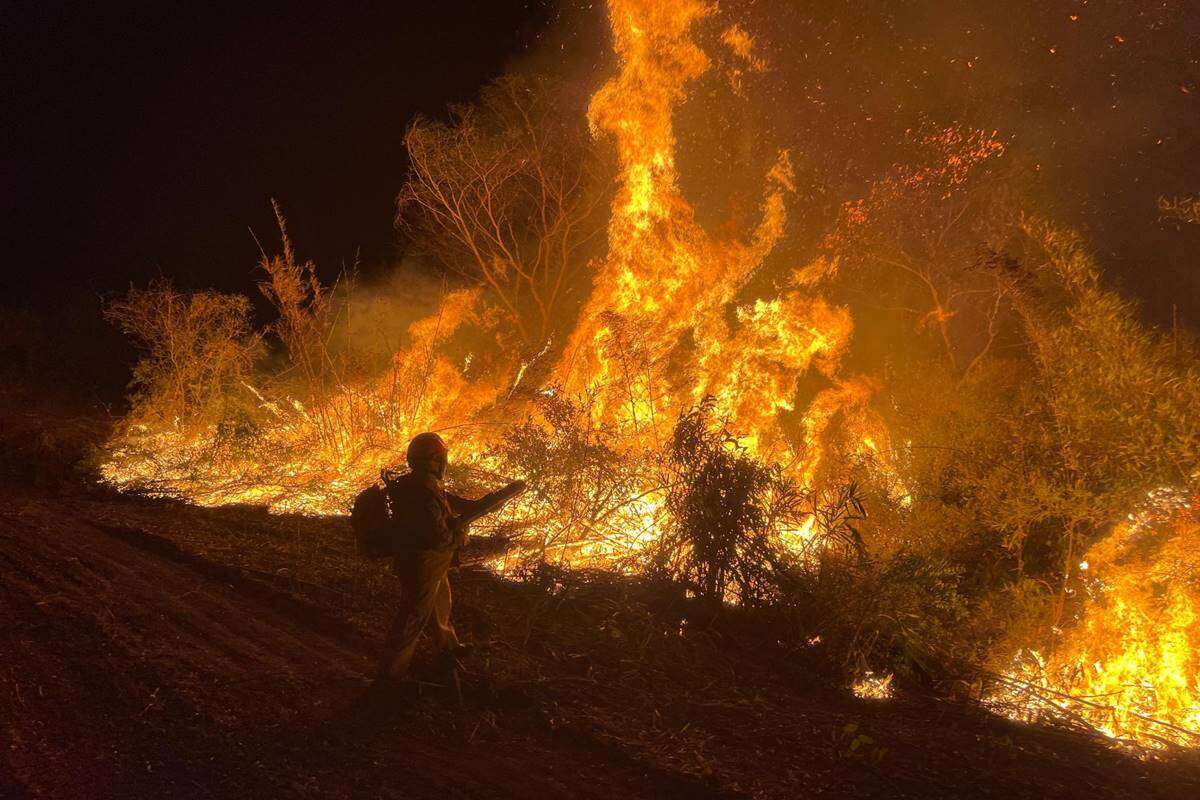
[396,76,608,354]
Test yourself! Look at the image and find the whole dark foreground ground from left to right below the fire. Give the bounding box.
[0,483,1200,799]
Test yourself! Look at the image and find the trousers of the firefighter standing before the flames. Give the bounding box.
[379,549,458,679]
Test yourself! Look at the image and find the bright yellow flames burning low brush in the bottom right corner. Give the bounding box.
[991,492,1200,746]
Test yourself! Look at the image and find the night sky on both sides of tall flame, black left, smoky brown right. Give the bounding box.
[0,0,1200,398]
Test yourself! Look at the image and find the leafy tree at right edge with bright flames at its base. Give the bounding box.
[986,224,1200,745]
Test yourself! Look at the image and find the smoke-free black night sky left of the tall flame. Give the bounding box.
[0,0,545,303]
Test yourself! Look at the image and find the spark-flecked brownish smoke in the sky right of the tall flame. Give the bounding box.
[720,0,1200,321]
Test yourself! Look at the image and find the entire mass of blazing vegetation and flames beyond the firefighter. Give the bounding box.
[102,0,1200,746]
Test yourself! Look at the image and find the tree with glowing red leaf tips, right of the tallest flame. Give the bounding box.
[824,126,1022,372]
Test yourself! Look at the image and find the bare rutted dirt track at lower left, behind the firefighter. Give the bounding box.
[0,495,713,798]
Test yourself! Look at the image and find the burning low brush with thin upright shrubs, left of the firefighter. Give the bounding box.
[102,209,505,513]
